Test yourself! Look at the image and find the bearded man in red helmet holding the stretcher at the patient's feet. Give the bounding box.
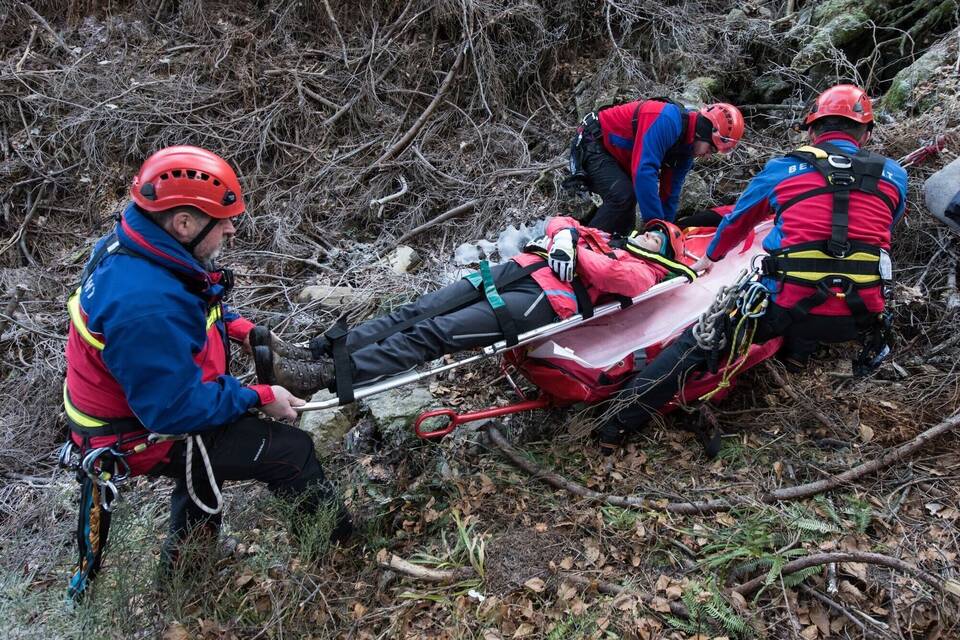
[64,146,352,591]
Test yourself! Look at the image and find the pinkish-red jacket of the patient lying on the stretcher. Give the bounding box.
[513,217,667,319]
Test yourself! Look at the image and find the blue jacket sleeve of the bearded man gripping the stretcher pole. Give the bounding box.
[103,297,259,434]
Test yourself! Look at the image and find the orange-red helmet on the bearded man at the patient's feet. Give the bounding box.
[130,145,245,219]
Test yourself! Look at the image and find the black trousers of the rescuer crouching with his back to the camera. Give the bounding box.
[600,303,859,444]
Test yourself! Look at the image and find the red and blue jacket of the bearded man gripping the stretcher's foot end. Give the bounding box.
[64,204,274,470]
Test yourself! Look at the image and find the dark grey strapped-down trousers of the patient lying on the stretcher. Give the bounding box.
[347,261,557,382]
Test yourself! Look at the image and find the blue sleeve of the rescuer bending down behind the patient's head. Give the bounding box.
[633,104,681,222]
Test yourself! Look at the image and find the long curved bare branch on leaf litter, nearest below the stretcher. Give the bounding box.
[487,411,960,515]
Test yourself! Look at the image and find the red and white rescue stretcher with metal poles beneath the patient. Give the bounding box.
[296,220,779,439]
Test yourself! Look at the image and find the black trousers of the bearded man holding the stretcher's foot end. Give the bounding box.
[150,415,349,543]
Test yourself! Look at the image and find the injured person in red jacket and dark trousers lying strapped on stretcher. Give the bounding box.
[250,217,696,401]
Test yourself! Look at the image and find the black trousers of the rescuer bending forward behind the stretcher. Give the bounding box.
[582,136,637,235]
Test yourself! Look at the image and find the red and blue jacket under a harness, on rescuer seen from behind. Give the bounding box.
[707,132,907,316]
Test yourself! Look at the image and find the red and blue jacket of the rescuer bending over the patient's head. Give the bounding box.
[597,100,697,222]
